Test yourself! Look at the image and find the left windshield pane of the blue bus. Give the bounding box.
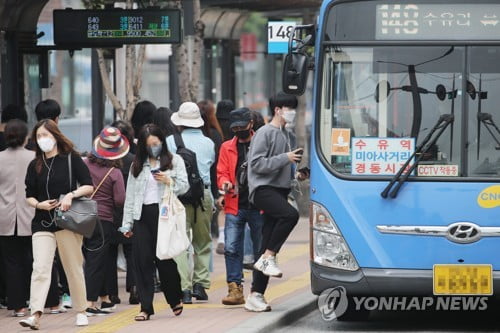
[318,46,472,177]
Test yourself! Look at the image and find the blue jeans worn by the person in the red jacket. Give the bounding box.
[224,209,264,285]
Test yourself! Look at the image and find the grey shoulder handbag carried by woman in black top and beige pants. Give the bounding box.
[55,154,114,238]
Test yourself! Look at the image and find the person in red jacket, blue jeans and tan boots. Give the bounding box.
[217,108,263,305]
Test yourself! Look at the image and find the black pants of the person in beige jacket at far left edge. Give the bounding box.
[0,236,33,310]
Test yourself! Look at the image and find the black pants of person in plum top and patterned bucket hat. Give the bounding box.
[83,221,116,302]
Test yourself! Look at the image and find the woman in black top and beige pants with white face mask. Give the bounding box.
[19,119,93,329]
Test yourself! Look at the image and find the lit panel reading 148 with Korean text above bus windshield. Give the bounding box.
[375,3,500,40]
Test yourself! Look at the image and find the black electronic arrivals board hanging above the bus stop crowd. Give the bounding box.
[54,9,182,48]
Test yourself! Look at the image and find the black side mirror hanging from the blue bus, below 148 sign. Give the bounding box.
[282,52,309,95]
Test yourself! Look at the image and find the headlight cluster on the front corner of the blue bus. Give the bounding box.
[311,203,359,271]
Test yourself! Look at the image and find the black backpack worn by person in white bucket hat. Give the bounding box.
[174,133,205,208]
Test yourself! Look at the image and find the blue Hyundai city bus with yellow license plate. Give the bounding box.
[283,0,500,316]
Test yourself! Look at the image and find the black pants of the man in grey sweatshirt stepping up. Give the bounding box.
[252,186,299,294]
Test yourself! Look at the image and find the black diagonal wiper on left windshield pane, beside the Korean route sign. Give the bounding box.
[380,114,455,199]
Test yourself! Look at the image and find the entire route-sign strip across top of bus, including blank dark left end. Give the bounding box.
[325,0,500,44]
